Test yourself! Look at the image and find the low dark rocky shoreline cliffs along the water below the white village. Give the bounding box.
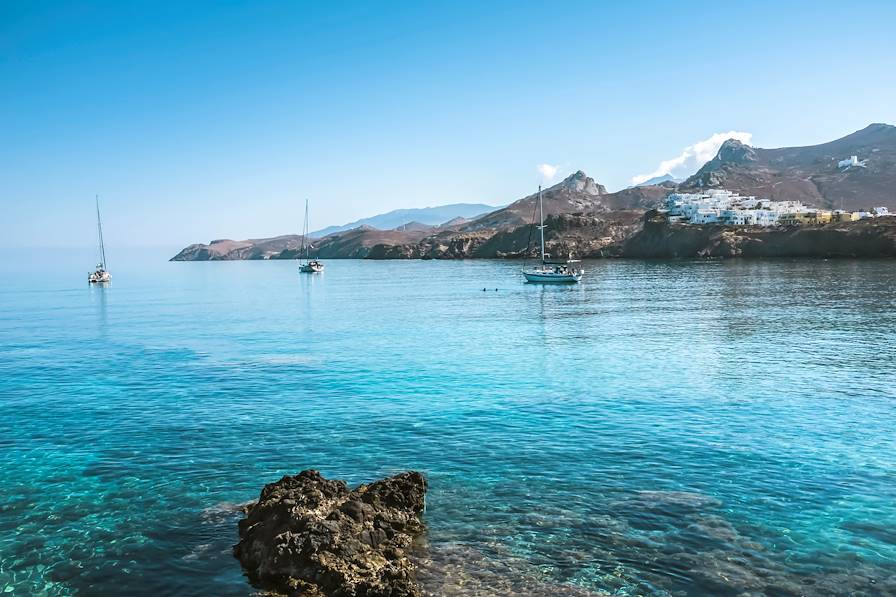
[174,210,896,261]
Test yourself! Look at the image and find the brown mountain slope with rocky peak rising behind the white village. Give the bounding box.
[681,124,896,210]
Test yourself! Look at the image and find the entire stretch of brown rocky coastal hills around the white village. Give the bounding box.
[173,124,896,261]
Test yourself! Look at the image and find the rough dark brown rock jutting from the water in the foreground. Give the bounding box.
[233,470,426,597]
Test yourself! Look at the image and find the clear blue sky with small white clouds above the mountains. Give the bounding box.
[0,0,896,250]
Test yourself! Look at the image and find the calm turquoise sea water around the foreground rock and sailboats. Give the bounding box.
[0,253,896,595]
